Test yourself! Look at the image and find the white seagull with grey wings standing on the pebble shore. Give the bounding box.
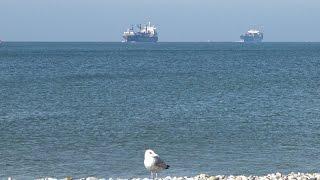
[144,149,170,179]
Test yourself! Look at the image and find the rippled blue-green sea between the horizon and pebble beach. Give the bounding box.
[0,42,320,180]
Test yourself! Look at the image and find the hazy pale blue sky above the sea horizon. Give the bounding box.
[0,0,320,41]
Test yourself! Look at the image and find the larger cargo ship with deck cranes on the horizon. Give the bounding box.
[122,22,158,42]
